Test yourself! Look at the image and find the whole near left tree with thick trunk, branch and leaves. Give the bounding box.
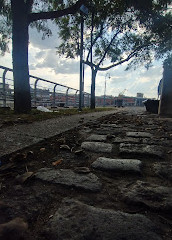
[0,0,86,113]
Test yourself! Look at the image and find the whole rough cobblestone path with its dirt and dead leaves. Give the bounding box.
[0,108,172,240]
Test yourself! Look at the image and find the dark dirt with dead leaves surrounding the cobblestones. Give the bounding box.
[0,108,172,240]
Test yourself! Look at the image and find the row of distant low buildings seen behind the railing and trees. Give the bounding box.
[0,83,146,107]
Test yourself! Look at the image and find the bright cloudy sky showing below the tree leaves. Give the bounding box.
[0,20,163,98]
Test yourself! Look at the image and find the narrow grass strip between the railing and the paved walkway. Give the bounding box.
[0,108,114,125]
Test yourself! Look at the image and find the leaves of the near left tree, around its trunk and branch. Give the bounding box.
[0,0,84,55]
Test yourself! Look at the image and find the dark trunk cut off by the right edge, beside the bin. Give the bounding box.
[159,63,172,117]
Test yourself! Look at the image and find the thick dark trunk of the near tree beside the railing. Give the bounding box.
[11,0,31,113]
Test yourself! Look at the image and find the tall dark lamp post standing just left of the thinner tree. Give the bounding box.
[79,5,88,111]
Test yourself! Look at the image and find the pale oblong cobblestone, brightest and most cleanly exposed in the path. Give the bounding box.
[92,157,142,173]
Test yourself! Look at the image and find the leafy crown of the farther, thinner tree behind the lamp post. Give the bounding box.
[57,0,172,71]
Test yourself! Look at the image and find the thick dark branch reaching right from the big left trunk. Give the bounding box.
[28,0,86,23]
